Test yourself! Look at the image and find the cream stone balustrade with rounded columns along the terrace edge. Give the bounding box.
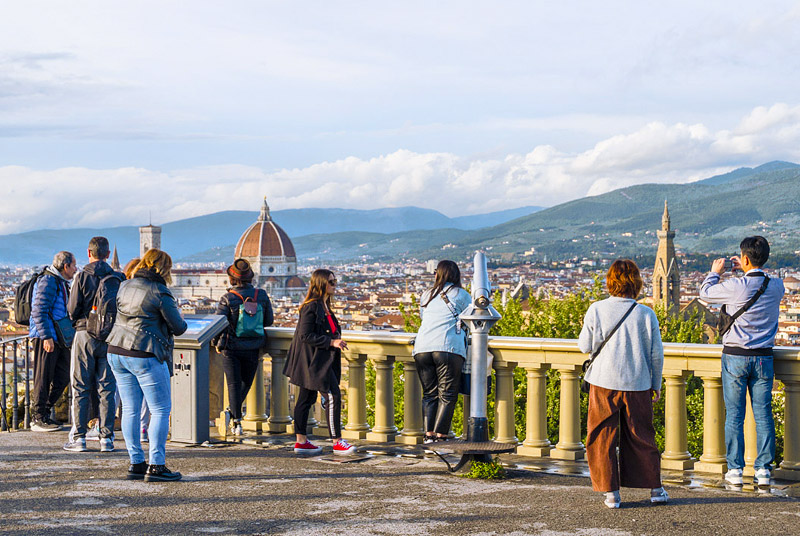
[260,328,800,480]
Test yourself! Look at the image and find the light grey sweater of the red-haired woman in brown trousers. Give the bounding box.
[578,296,664,391]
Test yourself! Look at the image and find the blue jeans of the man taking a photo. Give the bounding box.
[722,354,775,470]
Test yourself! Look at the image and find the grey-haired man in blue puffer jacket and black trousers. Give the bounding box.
[28,251,77,432]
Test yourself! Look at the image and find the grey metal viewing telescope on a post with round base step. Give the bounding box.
[431,251,517,471]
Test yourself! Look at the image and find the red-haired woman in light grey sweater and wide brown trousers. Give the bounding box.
[578,259,669,508]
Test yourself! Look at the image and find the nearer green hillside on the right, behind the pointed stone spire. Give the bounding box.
[223,162,800,260]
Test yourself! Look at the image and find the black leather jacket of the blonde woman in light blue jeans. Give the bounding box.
[106,270,187,363]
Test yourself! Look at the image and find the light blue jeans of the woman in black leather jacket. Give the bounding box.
[108,353,172,465]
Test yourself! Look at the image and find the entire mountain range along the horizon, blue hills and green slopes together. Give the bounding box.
[0,162,800,264]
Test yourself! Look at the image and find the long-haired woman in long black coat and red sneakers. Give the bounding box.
[283,268,356,454]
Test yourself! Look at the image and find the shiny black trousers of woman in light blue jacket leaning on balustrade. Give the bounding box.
[414,352,464,435]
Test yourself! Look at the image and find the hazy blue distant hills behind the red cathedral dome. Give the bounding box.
[0,207,541,264]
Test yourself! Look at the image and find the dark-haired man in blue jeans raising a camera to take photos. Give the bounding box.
[700,236,784,486]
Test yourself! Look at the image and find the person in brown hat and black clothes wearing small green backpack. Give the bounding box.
[214,259,274,436]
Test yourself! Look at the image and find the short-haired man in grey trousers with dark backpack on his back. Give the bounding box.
[64,236,125,452]
